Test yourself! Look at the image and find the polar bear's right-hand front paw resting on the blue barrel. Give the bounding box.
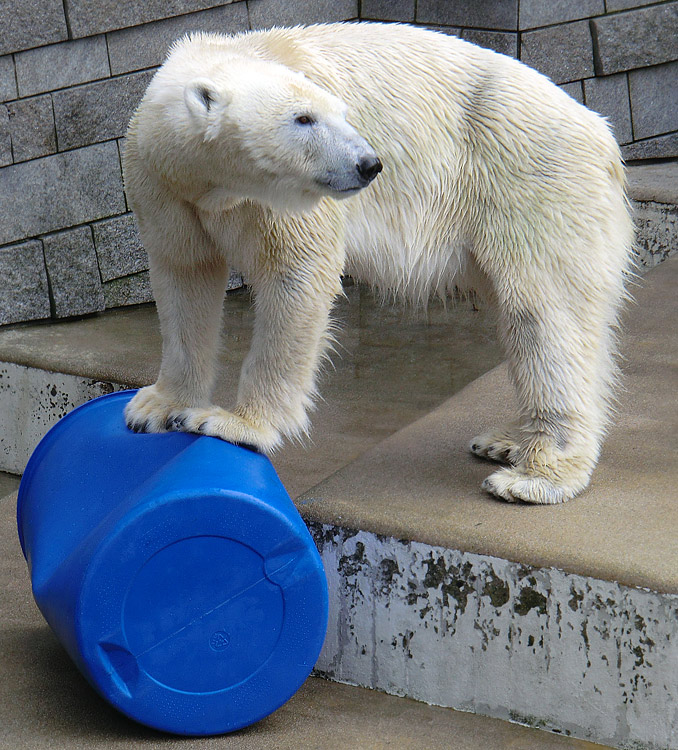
[165,406,281,453]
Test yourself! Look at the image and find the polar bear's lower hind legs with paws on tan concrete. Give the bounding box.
[484,279,616,504]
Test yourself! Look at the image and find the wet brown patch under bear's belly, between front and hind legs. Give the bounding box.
[273,286,503,497]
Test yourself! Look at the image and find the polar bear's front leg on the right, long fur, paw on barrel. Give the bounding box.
[159,209,344,453]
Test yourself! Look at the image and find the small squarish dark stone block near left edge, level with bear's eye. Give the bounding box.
[7,94,56,162]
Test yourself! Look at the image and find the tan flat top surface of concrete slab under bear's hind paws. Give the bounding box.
[300,258,678,594]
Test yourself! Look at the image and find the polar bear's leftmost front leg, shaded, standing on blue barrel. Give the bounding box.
[125,188,240,440]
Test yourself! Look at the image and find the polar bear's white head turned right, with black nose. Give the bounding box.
[177,58,382,210]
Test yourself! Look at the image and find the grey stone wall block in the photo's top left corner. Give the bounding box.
[0,0,68,55]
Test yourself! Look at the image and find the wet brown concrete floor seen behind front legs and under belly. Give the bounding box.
[0,285,502,497]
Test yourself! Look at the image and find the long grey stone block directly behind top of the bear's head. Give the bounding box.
[108,2,249,75]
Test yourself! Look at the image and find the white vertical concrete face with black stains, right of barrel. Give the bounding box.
[311,523,678,750]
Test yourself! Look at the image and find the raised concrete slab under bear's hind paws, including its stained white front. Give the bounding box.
[299,259,678,750]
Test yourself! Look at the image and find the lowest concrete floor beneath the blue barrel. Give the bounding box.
[0,488,600,750]
